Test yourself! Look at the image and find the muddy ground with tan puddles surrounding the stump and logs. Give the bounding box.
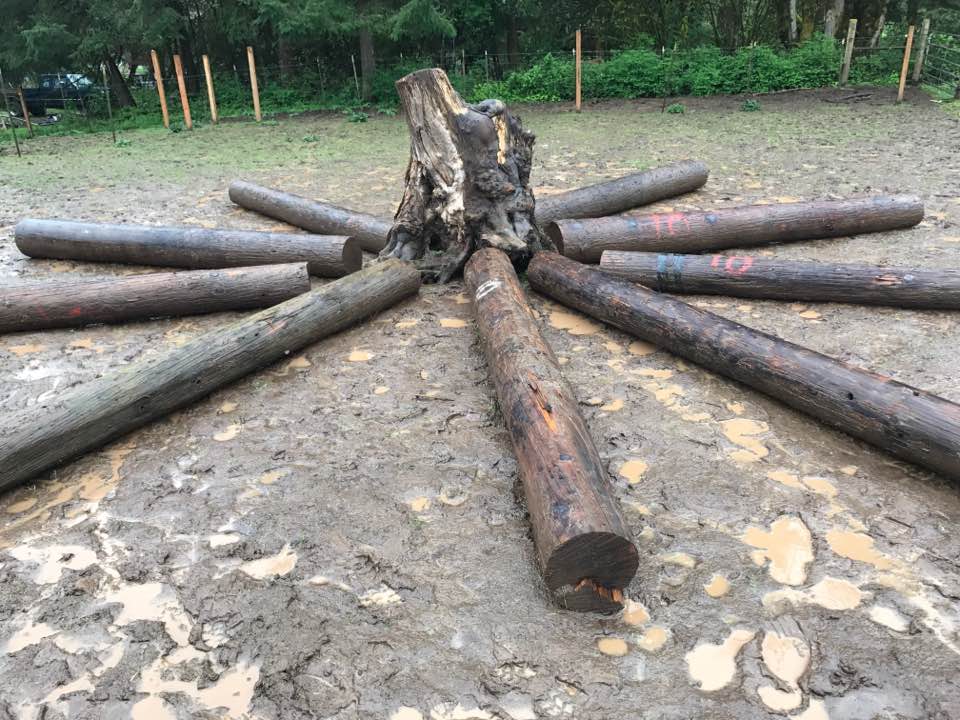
[0,90,960,720]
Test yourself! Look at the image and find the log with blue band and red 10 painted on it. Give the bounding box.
[600,250,960,310]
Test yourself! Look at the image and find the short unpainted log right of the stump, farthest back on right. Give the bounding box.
[537,160,710,226]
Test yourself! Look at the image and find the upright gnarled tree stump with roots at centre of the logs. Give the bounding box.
[381,68,552,282]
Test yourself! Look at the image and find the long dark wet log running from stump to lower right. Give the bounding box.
[528,253,960,480]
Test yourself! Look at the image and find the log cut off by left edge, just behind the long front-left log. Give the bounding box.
[0,263,310,333]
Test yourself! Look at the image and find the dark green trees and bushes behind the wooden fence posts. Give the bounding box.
[0,0,960,129]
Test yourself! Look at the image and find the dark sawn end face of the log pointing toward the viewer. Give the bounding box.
[544,532,640,612]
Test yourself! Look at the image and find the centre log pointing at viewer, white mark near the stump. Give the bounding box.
[464,248,638,612]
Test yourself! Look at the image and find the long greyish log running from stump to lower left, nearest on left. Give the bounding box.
[0,261,420,490]
